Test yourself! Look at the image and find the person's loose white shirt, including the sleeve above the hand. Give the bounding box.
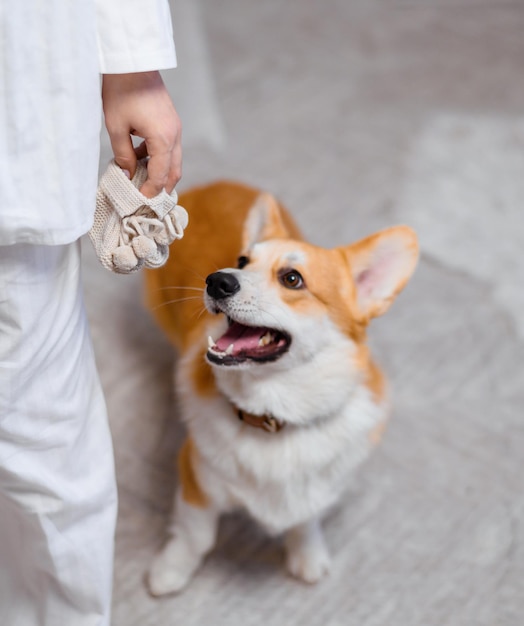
[0,0,176,245]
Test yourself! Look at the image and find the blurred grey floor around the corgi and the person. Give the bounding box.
[84,0,524,626]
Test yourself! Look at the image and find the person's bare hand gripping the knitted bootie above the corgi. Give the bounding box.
[102,72,182,198]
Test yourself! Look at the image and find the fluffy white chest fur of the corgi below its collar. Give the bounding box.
[177,342,386,533]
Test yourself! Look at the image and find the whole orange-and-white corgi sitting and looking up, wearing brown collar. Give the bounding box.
[146,182,418,596]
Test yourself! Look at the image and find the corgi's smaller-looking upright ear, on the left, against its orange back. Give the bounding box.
[242,193,290,250]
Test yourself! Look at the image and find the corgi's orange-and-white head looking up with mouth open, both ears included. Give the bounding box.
[205,194,418,369]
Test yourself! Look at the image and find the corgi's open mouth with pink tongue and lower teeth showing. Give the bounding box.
[207,319,291,365]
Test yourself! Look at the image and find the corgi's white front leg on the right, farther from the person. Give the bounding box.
[285,519,331,583]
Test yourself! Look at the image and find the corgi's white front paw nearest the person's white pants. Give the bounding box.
[148,537,202,596]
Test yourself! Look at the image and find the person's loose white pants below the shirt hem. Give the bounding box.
[0,242,116,626]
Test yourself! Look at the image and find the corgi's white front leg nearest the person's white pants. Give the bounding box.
[149,489,219,596]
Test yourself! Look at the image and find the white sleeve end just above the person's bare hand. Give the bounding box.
[96,0,176,74]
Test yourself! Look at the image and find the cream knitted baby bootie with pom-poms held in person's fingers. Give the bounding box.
[89,159,188,274]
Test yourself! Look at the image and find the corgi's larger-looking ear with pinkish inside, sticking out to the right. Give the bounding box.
[341,226,419,319]
